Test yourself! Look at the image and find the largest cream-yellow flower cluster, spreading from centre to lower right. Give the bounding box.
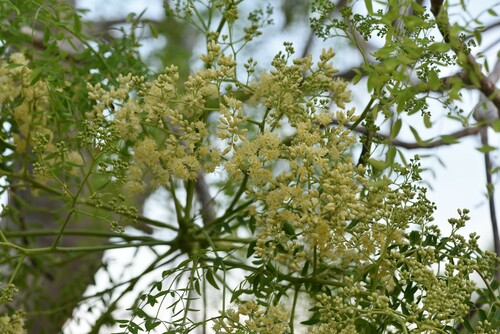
[198,45,491,333]
